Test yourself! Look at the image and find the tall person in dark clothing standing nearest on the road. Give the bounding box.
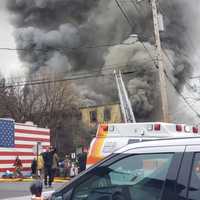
[43,147,53,187]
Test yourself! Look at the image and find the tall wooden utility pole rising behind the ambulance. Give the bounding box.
[151,0,169,122]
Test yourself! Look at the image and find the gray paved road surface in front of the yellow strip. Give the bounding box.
[0,182,63,200]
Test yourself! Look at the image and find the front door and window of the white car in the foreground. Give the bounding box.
[53,146,185,200]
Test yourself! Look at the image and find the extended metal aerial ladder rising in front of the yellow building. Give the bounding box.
[114,70,136,123]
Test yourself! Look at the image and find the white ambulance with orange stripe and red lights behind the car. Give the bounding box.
[86,122,200,168]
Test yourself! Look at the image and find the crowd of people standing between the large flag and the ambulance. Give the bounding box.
[14,146,87,187]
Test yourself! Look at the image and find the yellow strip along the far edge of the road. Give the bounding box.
[0,177,70,183]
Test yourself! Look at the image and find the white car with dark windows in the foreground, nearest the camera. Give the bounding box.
[51,137,200,200]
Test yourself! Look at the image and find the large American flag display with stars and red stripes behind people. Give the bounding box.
[0,119,50,173]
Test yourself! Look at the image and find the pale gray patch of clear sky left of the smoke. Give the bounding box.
[0,0,24,77]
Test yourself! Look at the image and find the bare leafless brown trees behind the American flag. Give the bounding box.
[0,74,90,154]
